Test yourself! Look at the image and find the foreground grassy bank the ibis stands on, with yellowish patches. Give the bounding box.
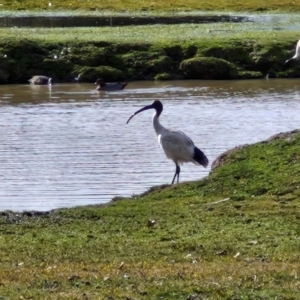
[0,132,300,299]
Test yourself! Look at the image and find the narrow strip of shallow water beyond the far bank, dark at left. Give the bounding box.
[0,10,300,34]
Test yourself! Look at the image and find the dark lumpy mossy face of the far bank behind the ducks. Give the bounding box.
[0,39,300,84]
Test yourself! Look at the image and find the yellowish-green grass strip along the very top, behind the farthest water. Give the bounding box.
[1,0,300,12]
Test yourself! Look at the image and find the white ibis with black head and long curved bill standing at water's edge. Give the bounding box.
[127,100,208,184]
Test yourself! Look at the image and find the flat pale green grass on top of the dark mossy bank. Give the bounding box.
[0,23,297,44]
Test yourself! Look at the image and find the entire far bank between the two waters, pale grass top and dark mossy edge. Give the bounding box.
[0,27,300,83]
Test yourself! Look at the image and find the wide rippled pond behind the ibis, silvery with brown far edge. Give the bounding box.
[0,80,300,211]
